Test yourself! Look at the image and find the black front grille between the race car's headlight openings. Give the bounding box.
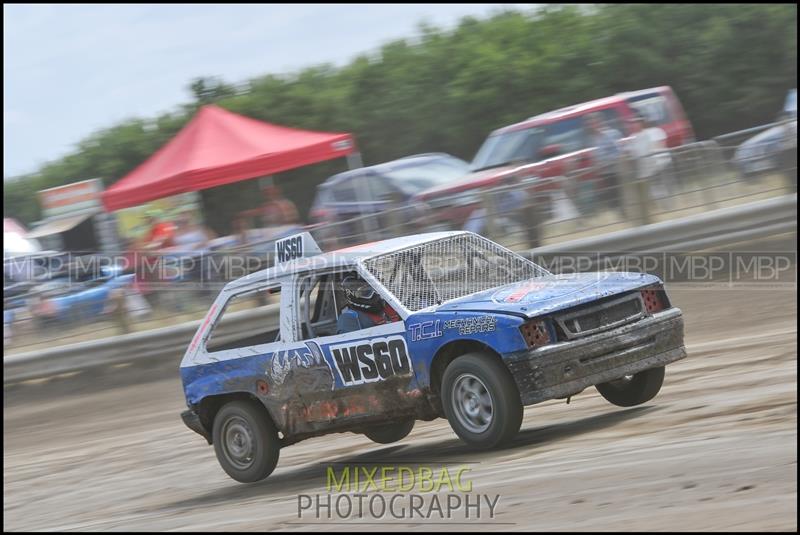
[555,292,645,340]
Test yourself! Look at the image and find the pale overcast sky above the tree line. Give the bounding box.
[3,4,532,179]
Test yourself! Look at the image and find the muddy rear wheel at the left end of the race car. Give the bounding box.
[212,401,280,483]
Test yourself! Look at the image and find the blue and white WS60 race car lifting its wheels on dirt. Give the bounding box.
[180,232,686,482]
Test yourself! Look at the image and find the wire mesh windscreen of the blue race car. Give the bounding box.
[364,234,549,311]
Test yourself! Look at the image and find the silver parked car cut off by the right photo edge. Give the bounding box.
[733,89,797,177]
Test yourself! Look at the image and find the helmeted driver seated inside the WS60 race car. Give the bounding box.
[337,273,400,334]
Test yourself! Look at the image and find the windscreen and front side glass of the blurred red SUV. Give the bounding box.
[470,117,587,171]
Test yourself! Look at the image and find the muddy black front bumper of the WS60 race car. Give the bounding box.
[504,308,686,405]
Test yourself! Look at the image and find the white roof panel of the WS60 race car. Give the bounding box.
[223,231,469,291]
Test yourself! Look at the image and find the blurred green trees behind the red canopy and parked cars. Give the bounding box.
[4,4,797,232]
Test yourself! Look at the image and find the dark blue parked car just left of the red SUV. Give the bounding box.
[309,153,469,241]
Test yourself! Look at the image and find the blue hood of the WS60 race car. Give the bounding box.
[436,272,661,317]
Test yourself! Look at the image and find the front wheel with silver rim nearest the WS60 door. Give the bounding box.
[441,353,523,450]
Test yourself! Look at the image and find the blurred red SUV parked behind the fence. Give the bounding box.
[414,86,694,228]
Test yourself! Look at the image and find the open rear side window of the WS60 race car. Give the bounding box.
[206,284,281,353]
